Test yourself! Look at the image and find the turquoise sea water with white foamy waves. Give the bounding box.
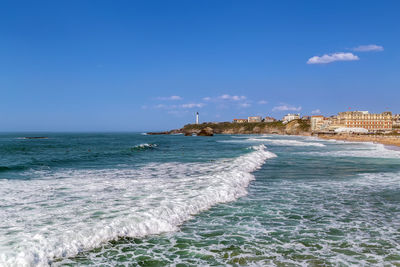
[0,134,400,266]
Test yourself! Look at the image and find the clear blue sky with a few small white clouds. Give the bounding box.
[0,0,400,132]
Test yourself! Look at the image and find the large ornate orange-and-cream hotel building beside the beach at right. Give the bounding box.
[336,111,393,132]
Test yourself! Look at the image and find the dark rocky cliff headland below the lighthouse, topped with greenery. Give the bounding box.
[181,120,311,135]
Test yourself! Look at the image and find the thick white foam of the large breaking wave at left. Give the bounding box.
[0,145,276,266]
